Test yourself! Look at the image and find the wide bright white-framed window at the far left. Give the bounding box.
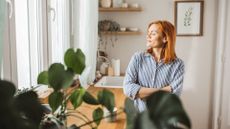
[1,0,47,88]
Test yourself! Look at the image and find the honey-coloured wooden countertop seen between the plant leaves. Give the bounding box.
[67,86,126,129]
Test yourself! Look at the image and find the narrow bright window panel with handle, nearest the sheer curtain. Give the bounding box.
[48,0,70,64]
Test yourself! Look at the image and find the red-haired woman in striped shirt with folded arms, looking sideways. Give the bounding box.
[124,21,184,112]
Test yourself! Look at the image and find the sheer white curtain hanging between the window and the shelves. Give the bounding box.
[72,0,98,84]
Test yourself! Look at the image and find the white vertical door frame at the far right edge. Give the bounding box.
[212,0,229,129]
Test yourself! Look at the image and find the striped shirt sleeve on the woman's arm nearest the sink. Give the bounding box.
[123,54,141,99]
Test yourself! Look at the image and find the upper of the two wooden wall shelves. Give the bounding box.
[99,7,142,12]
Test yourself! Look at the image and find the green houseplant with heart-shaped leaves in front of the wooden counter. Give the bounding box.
[38,48,115,129]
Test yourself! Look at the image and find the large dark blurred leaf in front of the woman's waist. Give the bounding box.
[146,91,191,129]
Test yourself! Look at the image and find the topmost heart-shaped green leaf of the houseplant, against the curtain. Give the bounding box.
[64,48,85,74]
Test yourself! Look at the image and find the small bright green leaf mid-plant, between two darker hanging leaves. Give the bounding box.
[70,88,85,109]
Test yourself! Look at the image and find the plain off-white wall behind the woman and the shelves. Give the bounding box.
[99,0,218,129]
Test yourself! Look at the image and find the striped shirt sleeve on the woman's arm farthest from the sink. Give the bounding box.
[170,62,185,96]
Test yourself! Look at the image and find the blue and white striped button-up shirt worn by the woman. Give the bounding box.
[123,52,184,112]
